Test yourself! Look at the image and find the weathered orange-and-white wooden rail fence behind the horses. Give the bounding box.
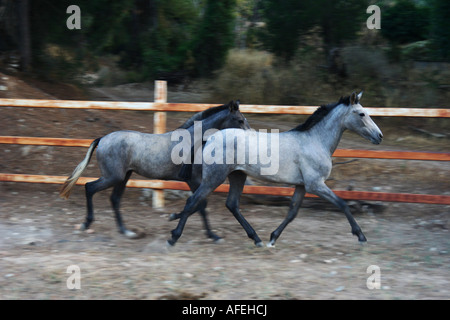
[0,81,450,207]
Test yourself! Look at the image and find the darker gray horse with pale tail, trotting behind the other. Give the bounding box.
[60,101,250,240]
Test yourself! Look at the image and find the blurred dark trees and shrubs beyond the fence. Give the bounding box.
[0,0,450,107]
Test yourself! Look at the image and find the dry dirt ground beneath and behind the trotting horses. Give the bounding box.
[0,74,450,299]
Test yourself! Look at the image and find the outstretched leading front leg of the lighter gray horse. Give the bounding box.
[306,182,367,243]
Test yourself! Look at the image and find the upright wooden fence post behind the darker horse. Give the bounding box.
[152,81,167,208]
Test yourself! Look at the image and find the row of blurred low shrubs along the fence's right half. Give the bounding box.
[213,46,450,107]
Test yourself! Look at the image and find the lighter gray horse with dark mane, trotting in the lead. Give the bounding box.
[168,92,383,246]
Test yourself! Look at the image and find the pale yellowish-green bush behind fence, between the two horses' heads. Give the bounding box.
[210,49,330,105]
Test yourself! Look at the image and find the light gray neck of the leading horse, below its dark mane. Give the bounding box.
[309,104,346,157]
